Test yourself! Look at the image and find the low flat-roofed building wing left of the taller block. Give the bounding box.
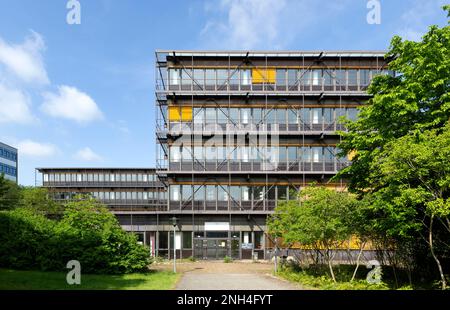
[37,168,167,255]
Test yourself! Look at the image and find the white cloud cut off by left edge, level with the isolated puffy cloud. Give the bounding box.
[0,83,35,124]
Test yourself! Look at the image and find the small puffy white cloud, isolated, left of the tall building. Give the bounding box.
[41,85,103,123]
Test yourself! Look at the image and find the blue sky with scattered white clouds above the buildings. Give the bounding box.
[0,0,447,185]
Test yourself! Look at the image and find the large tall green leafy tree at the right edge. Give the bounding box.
[337,6,450,288]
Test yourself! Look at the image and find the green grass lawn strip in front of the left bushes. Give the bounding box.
[0,269,180,290]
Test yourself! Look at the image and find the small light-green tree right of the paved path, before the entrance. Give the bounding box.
[268,186,356,282]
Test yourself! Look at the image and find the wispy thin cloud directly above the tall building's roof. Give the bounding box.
[200,0,350,50]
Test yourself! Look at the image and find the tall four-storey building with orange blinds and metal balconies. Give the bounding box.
[155,50,390,259]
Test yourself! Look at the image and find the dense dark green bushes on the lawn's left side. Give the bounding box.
[0,198,151,274]
